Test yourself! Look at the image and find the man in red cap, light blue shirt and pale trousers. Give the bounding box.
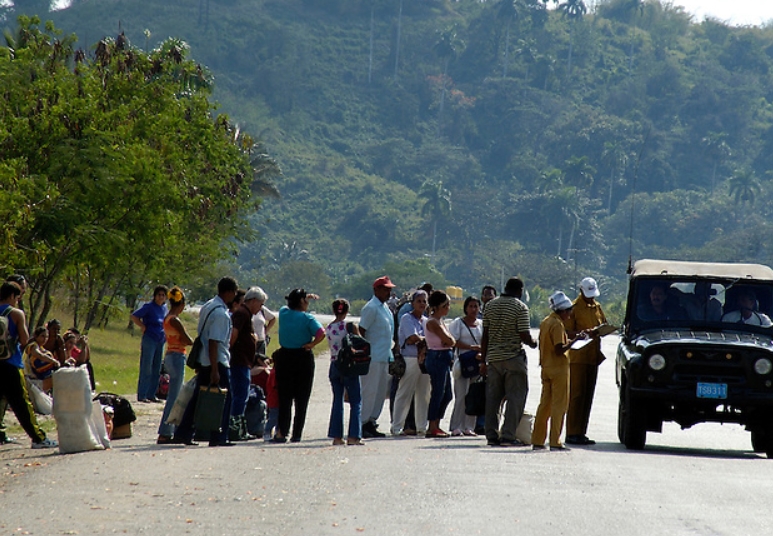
[360,276,395,438]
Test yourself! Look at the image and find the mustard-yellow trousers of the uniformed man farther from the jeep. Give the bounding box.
[531,366,569,447]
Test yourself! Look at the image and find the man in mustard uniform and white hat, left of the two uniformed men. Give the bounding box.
[531,292,584,450]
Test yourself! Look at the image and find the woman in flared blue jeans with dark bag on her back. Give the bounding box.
[325,299,365,445]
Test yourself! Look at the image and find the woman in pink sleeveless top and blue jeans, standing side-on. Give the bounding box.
[424,290,456,437]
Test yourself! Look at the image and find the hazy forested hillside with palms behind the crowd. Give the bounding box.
[10,0,773,310]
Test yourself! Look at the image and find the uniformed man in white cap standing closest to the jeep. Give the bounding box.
[564,277,607,445]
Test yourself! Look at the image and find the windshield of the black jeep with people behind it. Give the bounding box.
[628,277,773,333]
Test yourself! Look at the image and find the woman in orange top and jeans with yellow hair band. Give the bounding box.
[156,287,193,445]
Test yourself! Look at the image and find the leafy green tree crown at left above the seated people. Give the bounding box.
[0,16,279,328]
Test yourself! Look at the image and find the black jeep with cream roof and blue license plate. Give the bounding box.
[616,260,773,458]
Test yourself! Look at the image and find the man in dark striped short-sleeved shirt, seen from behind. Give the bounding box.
[481,277,537,446]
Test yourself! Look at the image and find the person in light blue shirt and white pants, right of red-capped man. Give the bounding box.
[392,290,430,436]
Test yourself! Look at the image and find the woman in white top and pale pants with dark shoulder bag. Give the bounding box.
[448,296,483,436]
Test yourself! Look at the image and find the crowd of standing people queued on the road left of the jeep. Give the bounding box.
[134,276,606,450]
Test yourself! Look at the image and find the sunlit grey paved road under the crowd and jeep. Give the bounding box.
[0,338,773,536]
